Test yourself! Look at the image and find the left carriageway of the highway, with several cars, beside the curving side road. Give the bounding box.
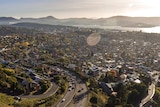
[56,84,76,107]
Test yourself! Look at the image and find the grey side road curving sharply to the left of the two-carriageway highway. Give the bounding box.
[20,82,58,98]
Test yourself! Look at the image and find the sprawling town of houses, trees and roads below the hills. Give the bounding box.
[0,23,160,107]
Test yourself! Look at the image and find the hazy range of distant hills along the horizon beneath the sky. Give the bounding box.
[0,16,160,27]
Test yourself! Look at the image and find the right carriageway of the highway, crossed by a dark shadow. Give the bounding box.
[67,80,88,107]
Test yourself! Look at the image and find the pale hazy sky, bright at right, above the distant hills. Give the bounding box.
[0,0,160,18]
